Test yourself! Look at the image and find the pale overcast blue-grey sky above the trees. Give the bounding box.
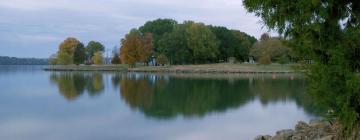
[0,0,267,58]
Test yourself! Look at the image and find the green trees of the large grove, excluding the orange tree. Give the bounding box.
[139,19,257,64]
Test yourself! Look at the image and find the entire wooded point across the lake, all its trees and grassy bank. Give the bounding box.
[46,19,299,73]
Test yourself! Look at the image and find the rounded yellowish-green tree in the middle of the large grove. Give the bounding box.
[159,21,219,64]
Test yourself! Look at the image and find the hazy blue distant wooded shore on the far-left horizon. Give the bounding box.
[0,56,48,65]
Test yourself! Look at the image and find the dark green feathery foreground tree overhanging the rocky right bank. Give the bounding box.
[243,0,360,133]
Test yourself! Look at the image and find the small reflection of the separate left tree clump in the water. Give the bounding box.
[50,72,104,100]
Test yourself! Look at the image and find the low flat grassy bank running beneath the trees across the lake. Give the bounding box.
[44,63,298,73]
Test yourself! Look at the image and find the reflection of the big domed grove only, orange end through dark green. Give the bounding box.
[116,75,251,118]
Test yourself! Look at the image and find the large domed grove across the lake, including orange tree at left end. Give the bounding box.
[120,19,257,66]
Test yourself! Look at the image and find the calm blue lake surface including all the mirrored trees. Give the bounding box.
[0,66,318,140]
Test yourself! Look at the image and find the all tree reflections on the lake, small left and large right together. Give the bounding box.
[50,73,324,119]
